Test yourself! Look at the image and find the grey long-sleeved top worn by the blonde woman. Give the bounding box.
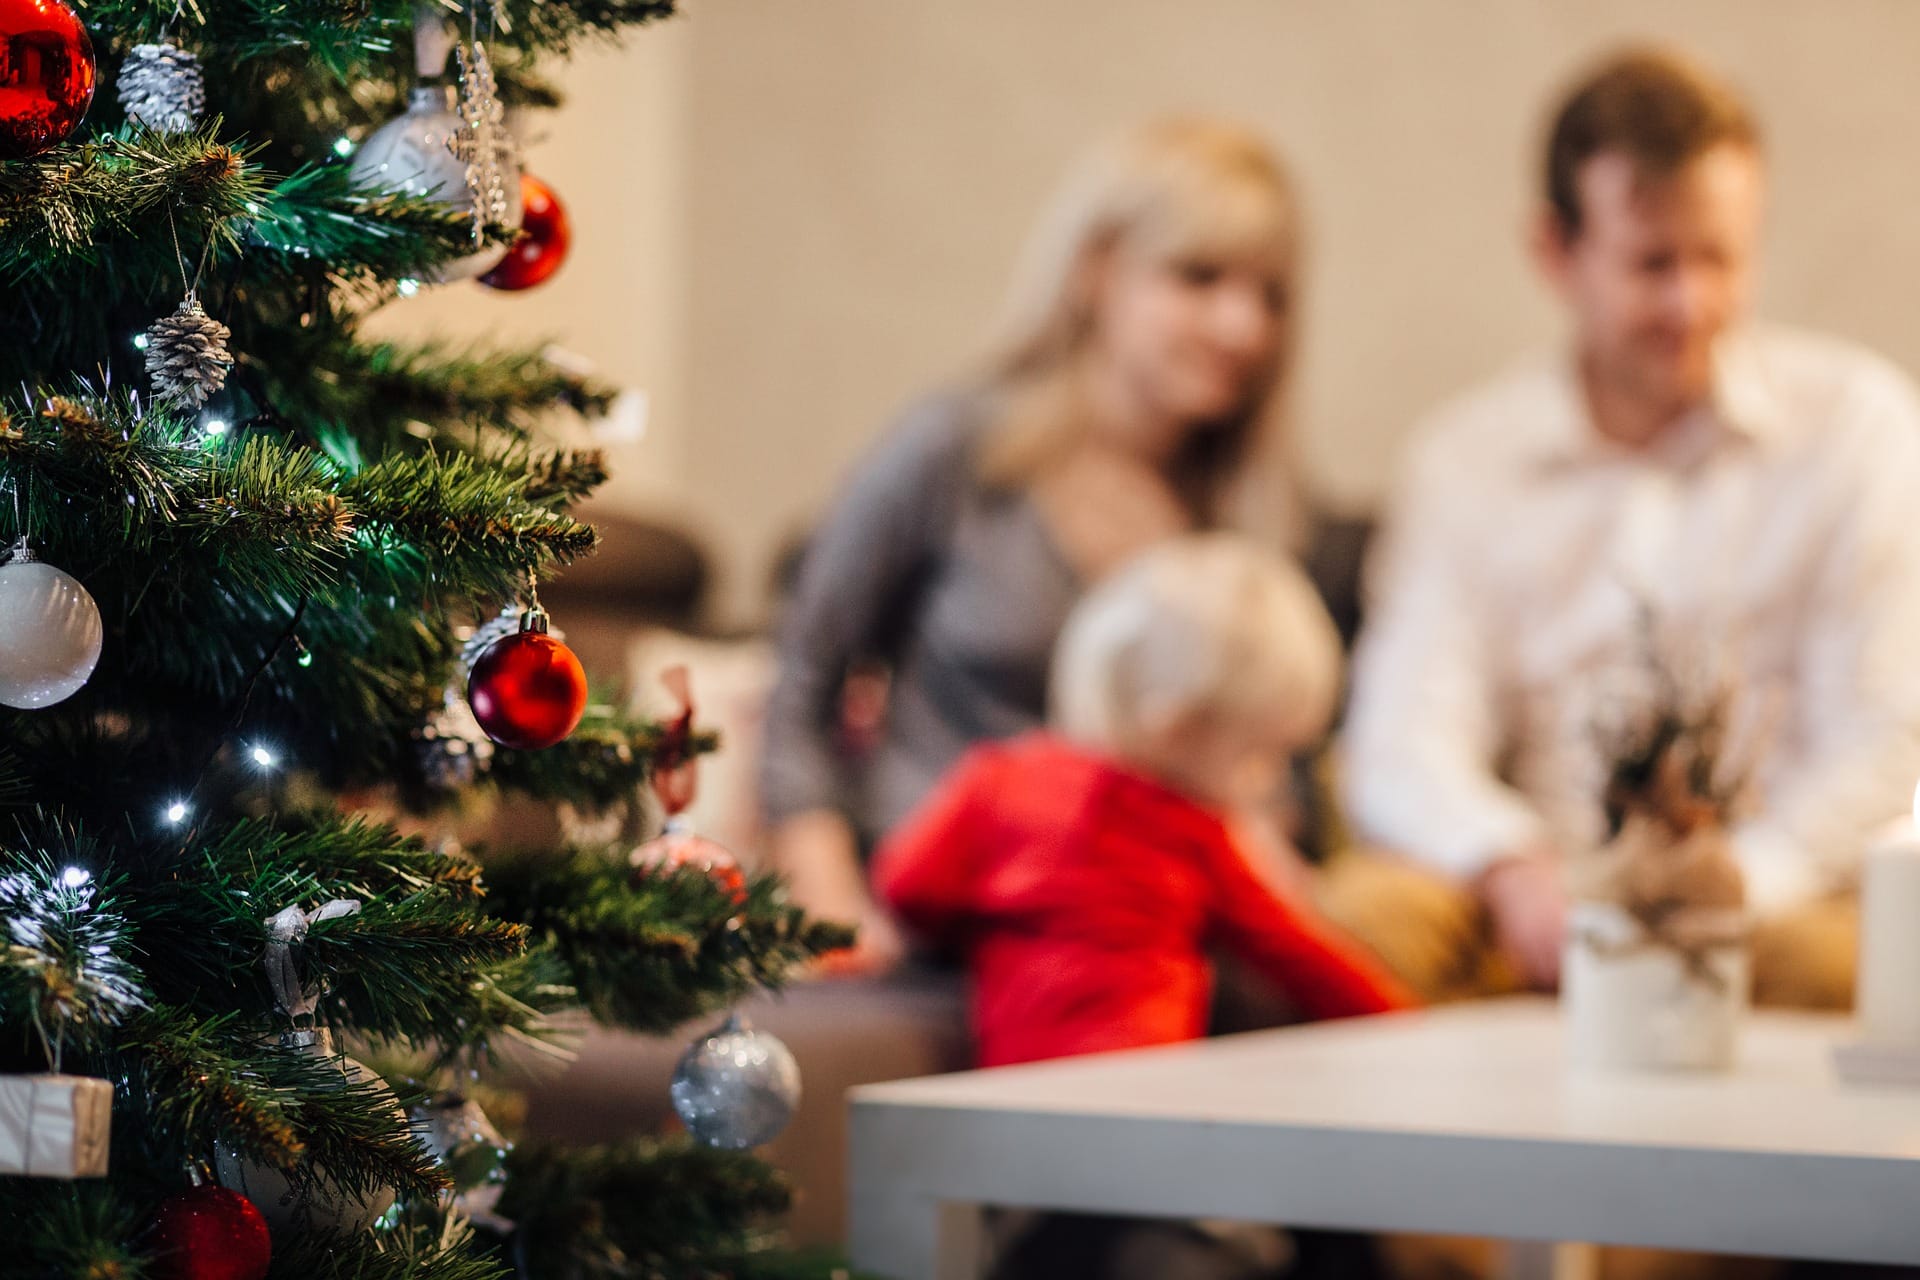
[760,391,1081,842]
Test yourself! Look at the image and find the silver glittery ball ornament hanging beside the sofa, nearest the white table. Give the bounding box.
[668,1013,801,1151]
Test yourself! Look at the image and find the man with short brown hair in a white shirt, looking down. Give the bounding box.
[1334,52,1920,1006]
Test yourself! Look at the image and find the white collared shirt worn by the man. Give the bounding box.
[1344,328,1920,912]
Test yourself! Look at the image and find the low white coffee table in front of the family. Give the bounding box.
[851,1000,1920,1280]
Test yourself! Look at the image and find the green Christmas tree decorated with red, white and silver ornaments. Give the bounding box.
[0,0,847,1280]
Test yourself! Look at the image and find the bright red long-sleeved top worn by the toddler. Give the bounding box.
[874,733,1413,1067]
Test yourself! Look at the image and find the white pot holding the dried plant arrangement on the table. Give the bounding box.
[1561,902,1751,1071]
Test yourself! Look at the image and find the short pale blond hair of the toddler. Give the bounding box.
[1050,533,1340,760]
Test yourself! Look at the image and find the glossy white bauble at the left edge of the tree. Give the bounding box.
[0,537,102,710]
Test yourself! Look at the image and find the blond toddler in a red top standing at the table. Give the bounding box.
[876,533,1413,1065]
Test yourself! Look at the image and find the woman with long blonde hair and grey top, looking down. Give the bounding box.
[762,121,1300,973]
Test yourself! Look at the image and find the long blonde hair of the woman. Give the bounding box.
[979,119,1300,533]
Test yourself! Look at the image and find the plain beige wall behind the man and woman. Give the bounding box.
[382,0,1920,616]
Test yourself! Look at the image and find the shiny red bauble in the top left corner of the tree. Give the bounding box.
[0,0,94,159]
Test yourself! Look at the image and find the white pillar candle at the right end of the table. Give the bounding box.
[1855,789,1920,1048]
